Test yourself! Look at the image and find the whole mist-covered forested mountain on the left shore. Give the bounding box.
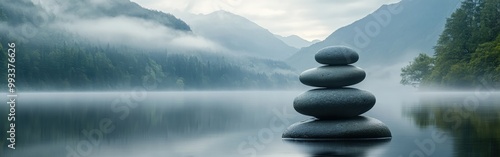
[0,0,297,91]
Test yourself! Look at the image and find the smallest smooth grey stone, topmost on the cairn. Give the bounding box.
[314,46,359,65]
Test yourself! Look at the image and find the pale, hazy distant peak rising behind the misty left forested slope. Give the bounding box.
[176,11,297,60]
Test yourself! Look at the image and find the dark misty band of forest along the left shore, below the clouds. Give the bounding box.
[10,43,294,91]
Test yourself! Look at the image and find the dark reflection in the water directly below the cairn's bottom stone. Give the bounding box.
[284,139,390,157]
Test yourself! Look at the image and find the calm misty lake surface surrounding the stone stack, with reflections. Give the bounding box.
[0,91,500,157]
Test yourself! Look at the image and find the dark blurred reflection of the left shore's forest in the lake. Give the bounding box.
[0,95,282,148]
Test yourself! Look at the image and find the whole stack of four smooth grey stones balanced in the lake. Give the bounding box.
[282,46,391,140]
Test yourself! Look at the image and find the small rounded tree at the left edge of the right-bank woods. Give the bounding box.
[401,53,434,86]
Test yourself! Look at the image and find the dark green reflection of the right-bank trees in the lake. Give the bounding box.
[404,93,500,156]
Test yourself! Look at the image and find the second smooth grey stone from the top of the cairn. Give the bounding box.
[299,65,366,88]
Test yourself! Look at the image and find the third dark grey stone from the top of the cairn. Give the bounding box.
[293,88,376,119]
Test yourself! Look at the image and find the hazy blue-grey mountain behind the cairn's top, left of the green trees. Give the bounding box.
[287,0,461,70]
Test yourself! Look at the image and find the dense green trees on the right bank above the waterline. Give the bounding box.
[401,0,500,88]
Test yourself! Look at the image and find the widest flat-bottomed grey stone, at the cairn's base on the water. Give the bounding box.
[282,116,392,140]
